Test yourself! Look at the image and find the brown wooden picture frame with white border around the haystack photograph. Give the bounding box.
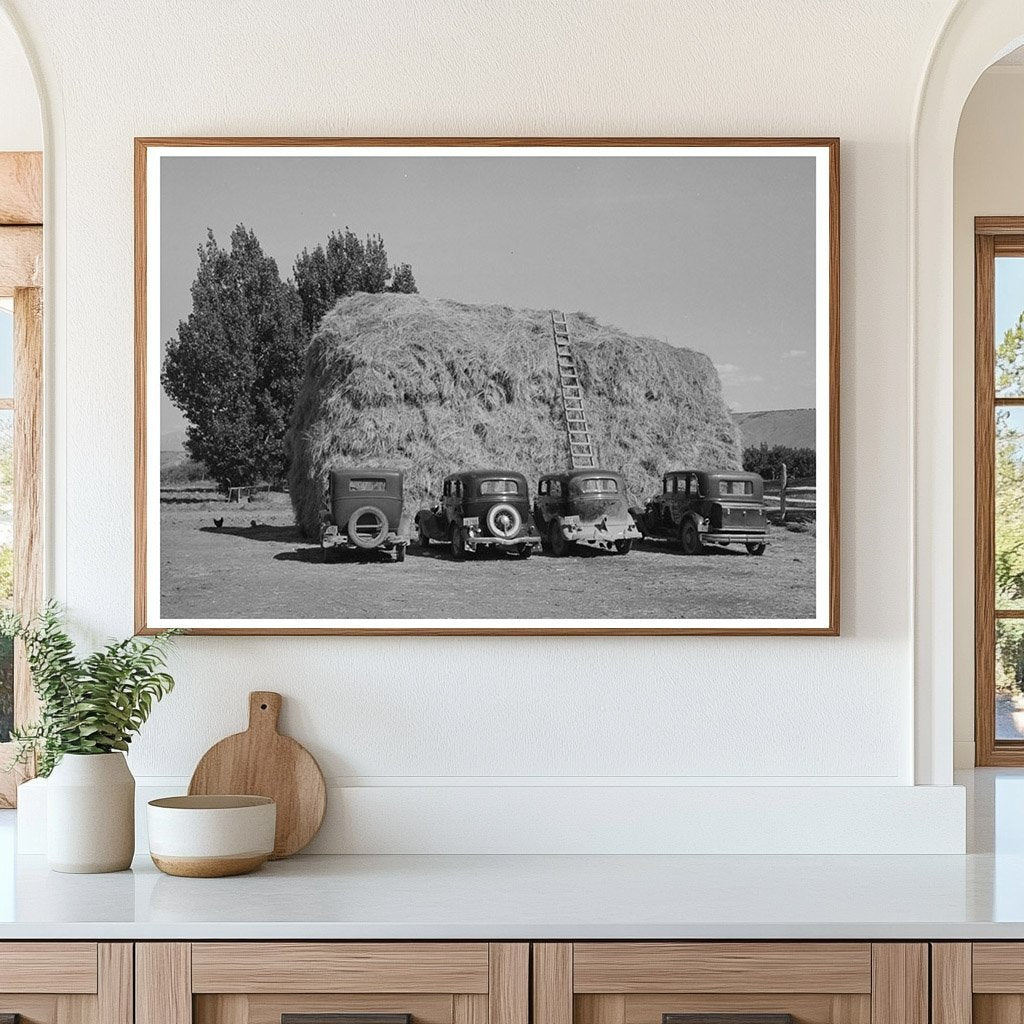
[135,137,840,636]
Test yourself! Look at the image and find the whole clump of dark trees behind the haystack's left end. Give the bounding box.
[163,224,417,488]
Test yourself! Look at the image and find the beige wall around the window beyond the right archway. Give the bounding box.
[952,65,1024,767]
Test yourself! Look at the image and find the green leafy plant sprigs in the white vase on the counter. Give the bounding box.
[0,602,179,776]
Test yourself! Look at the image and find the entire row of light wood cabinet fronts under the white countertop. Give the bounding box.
[0,942,987,1024]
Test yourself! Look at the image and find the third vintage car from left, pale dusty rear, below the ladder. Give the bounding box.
[534,469,640,556]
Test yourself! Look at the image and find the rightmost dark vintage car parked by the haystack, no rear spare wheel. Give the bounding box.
[631,469,768,555]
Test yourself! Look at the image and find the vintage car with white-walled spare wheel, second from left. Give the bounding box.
[414,469,541,559]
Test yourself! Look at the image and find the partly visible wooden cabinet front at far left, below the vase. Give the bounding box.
[0,942,132,1024]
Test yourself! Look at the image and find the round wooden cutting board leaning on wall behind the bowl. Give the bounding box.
[188,690,327,860]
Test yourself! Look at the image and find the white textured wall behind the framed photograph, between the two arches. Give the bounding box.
[6,0,963,845]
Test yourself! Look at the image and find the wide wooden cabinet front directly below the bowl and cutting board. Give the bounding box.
[136,942,529,1024]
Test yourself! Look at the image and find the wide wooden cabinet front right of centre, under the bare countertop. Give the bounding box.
[534,942,928,1024]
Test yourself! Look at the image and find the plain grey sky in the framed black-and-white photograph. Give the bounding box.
[160,155,815,435]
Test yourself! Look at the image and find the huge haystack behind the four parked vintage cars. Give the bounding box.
[289,294,739,537]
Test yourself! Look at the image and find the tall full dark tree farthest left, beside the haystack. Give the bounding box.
[163,224,306,487]
